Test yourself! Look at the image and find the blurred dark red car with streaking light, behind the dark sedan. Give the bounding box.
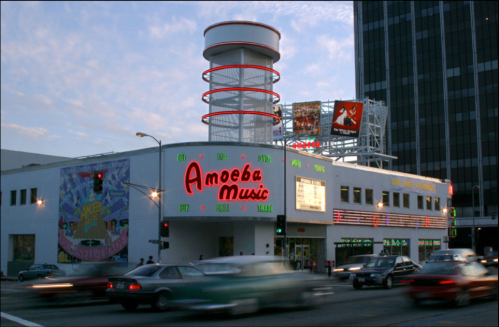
[29,262,128,300]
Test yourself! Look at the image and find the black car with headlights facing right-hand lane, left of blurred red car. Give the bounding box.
[349,255,423,290]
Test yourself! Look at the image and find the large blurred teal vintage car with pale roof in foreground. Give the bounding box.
[178,255,333,315]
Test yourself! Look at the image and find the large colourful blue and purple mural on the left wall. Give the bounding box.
[57,159,130,263]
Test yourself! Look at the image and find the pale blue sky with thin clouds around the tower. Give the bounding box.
[1,1,355,157]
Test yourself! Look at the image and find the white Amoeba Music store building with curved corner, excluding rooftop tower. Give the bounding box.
[1,142,451,276]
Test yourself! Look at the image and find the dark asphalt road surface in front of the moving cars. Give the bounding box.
[1,280,498,326]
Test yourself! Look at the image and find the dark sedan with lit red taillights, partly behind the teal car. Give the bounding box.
[106,264,205,311]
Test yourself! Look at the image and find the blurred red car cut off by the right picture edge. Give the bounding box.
[405,261,497,306]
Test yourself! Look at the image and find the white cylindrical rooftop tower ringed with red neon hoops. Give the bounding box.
[202,21,281,144]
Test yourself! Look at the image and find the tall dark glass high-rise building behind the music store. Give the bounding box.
[354,1,498,223]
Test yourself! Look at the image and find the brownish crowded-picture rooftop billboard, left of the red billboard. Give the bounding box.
[293,101,321,135]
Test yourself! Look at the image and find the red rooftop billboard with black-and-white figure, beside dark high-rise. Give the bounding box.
[331,101,364,137]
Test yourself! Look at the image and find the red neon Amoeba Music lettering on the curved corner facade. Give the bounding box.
[184,161,269,201]
